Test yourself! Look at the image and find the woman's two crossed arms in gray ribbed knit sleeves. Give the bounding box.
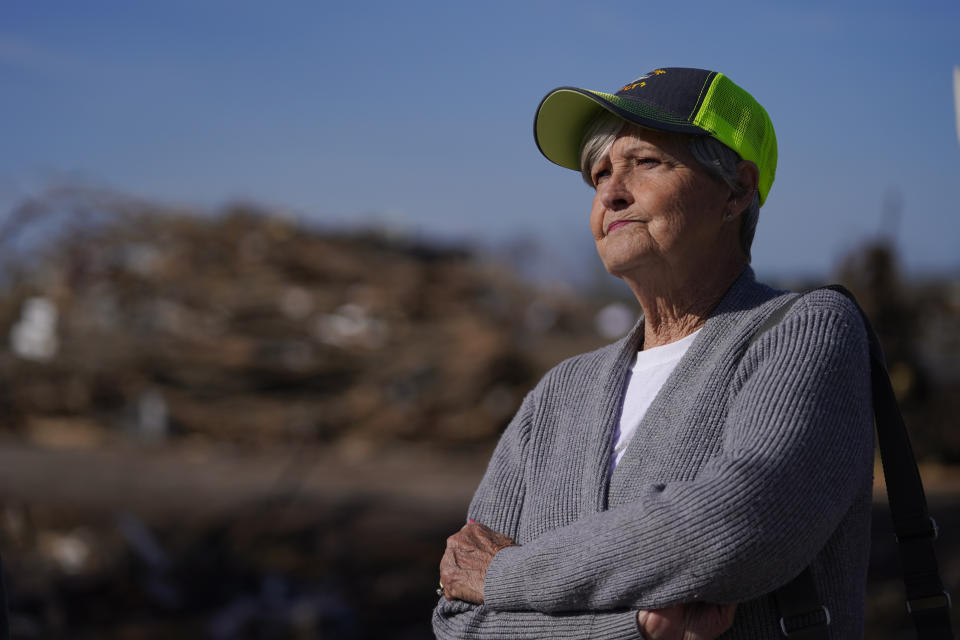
[434,302,873,638]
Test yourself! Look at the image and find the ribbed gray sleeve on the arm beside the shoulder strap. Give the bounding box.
[484,292,873,616]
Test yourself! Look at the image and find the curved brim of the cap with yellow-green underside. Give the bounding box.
[533,87,708,171]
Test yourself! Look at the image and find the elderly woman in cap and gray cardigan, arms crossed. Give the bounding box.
[433,68,873,640]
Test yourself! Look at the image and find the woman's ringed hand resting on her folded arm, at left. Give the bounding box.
[440,520,517,604]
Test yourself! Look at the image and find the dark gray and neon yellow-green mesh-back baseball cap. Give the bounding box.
[533,67,777,204]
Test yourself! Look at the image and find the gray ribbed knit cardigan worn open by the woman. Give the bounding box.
[433,267,873,640]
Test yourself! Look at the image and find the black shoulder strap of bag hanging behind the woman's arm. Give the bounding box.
[754,285,954,640]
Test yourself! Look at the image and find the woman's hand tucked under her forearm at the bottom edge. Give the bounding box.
[637,602,737,640]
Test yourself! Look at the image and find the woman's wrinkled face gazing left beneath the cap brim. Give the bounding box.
[590,129,739,277]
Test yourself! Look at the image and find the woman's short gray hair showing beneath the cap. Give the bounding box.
[580,111,760,262]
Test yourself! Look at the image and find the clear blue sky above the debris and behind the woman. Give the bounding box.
[0,0,960,282]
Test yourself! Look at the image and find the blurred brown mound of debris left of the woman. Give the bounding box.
[0,192,608,453]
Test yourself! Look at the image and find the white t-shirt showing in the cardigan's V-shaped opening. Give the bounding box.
[610,329,700,471]
